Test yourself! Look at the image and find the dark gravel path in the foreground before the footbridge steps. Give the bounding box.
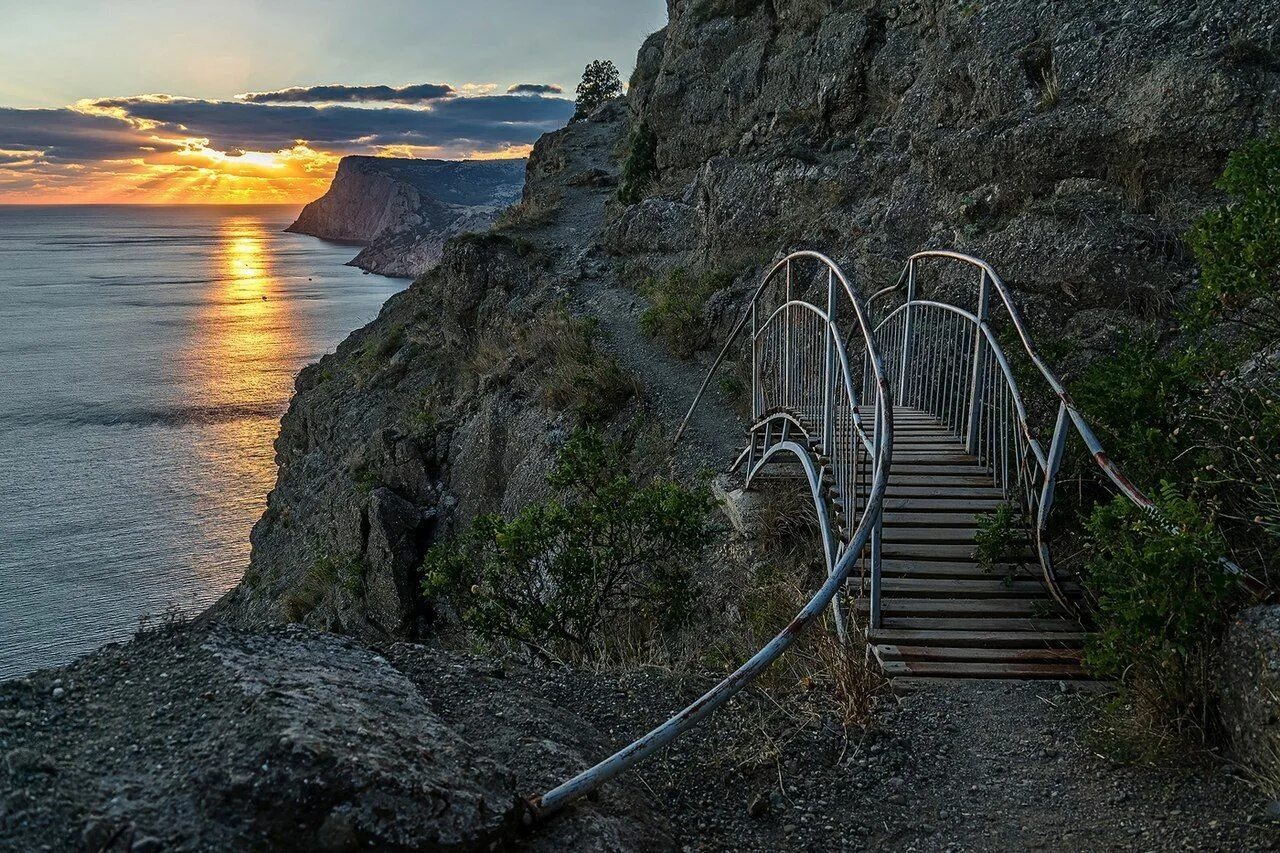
[401,645,1280,850]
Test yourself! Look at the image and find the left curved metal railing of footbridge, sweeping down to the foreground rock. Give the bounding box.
[530,251,893,816]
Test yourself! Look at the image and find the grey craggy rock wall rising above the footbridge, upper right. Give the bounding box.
[612,0,1280,345]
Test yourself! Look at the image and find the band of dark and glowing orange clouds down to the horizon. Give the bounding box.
[0,86,573,201]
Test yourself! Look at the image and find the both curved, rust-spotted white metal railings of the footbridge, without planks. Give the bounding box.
[530,242,1239,816]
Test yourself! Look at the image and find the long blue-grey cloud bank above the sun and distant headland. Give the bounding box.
[81,95,573,151]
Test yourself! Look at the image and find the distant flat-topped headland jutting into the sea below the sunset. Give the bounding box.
[285,156,525,278]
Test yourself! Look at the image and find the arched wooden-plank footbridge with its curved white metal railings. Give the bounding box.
[531,251,1172,813]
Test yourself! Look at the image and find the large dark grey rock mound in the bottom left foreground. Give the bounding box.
[0,626,669,853]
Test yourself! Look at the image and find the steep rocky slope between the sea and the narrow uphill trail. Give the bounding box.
[212,104,626,638]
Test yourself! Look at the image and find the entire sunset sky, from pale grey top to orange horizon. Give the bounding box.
[0,0,666,204]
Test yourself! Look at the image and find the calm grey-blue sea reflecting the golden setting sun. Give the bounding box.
[0,205,407,679]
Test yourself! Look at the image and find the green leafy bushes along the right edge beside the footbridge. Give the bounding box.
[1075,136,1280,736]
